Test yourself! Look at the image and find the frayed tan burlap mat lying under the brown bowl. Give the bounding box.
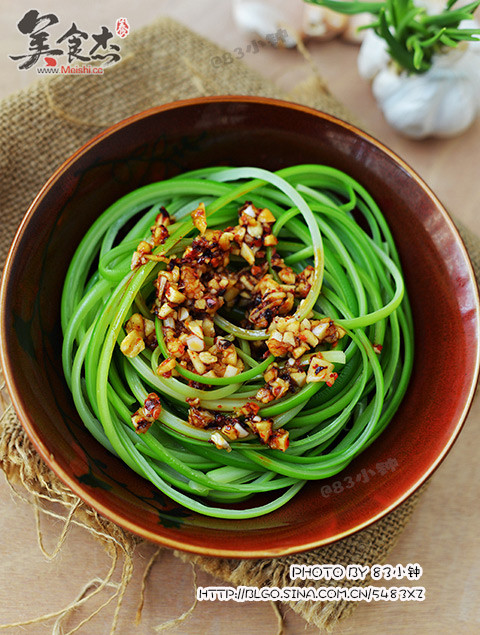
[0,14,472,628]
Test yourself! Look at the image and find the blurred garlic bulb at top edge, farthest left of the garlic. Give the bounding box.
[232,0,297,48]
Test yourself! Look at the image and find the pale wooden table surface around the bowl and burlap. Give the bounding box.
[0,0,480,635]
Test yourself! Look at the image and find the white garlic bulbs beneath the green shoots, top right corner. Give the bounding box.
[358,28,480,139]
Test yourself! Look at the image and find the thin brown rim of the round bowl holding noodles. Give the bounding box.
[0,95,480,559]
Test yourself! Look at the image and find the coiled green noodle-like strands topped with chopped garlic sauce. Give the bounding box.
[61,165,413,519]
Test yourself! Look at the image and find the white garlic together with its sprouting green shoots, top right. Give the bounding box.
[306,0,480,139]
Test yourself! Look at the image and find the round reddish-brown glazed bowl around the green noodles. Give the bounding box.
[1,97,479,557]
